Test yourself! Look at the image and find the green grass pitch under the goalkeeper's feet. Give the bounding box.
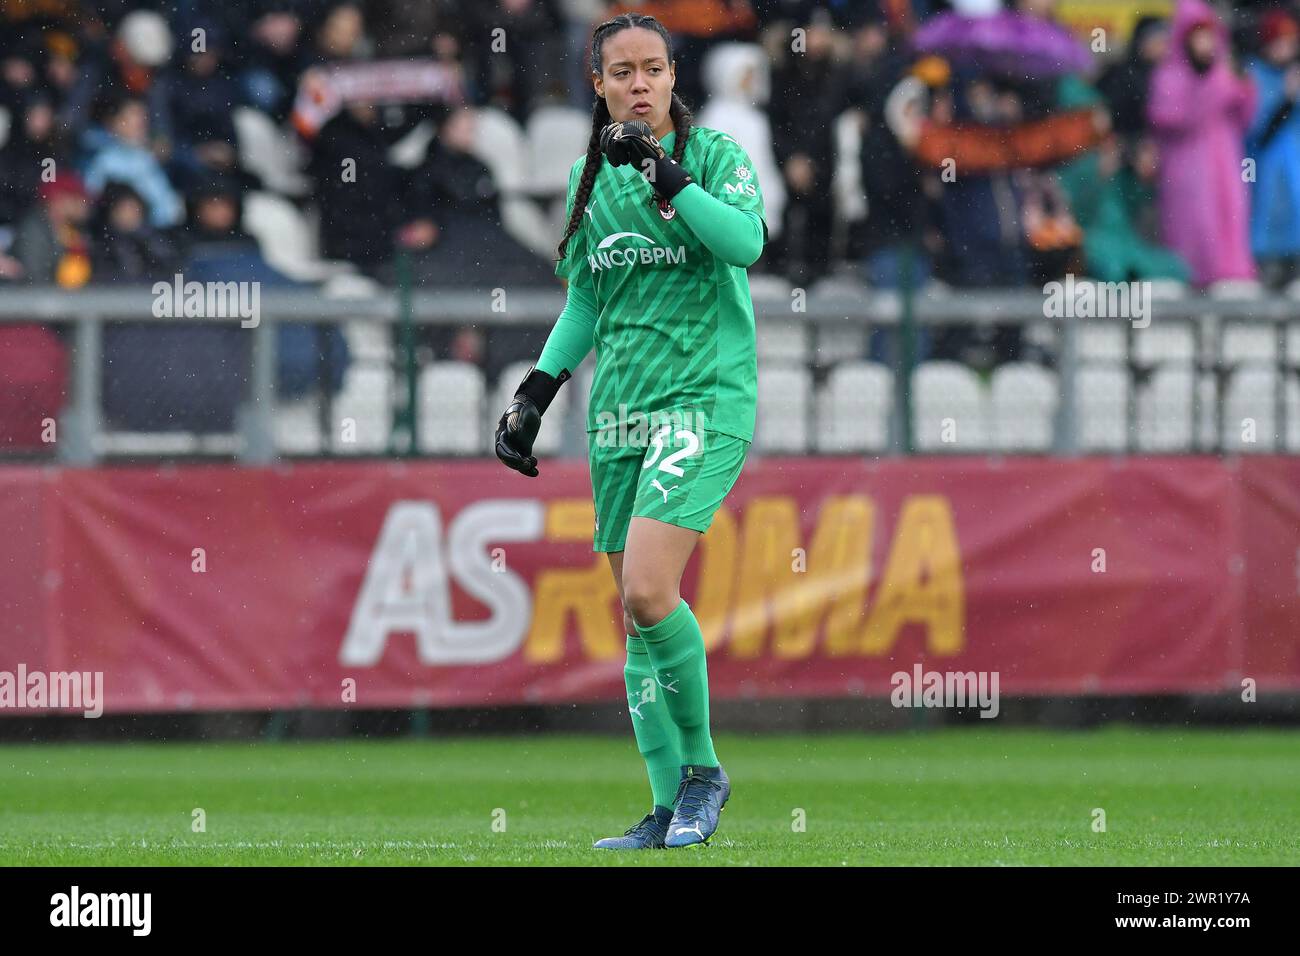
[0,726,1300,866]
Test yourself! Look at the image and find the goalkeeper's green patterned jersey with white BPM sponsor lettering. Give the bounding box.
[555,126,767,441]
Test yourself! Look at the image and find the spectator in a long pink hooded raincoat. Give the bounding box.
[1147,0,1256,287]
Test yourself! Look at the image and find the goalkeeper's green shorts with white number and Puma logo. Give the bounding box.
[586,425,749,551]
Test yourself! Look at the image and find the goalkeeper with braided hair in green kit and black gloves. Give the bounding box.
[497,14,767,849]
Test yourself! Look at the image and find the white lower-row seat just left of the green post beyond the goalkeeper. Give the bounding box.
[814,362,894,454]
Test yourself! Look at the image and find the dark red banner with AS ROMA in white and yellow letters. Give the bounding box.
[0,457,1300,714]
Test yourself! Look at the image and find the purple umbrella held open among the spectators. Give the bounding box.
[913,10,1092,79]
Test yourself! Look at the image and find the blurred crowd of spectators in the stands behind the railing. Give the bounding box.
[0,0,1300,442]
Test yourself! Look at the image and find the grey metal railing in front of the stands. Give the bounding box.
[0,286,1300,464]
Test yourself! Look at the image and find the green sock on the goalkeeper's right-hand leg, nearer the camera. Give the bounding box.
[637,601,718,767]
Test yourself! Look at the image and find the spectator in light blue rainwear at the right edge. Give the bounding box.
[1245,10,1300,286]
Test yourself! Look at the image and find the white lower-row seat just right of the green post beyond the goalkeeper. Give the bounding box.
[911,362,989,451]
